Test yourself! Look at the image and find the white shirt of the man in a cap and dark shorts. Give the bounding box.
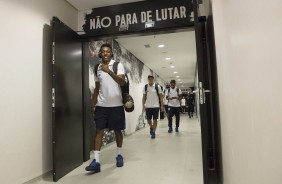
[143,83,163,108]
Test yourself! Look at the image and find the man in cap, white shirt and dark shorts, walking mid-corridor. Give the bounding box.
[142,75,163,139]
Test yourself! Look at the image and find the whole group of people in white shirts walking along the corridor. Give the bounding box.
[85,43,194,173]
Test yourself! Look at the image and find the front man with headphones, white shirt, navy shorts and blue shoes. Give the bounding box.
[85,43,125,172]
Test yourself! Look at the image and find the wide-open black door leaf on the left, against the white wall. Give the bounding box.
[52,17,83,181]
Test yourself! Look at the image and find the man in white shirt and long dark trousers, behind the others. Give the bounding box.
[166,80,182,133]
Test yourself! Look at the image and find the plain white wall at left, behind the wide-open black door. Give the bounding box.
[0,0,78,183]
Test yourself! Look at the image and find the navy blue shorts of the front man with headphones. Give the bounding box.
[94,106,125,130]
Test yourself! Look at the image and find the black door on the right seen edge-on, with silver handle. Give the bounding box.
[195,17,220,184]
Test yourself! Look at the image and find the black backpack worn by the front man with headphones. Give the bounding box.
[94,61,134,112]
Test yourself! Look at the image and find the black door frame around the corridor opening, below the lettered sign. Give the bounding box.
[51,0,221,184]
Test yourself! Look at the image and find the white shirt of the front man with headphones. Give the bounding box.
[94,60,124,107]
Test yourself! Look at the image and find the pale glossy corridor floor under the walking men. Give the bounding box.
[33,114,203,184]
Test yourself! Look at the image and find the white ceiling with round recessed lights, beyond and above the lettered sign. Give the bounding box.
[66,0,196,88]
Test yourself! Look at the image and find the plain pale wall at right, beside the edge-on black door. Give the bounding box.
[212,0,282,184]
